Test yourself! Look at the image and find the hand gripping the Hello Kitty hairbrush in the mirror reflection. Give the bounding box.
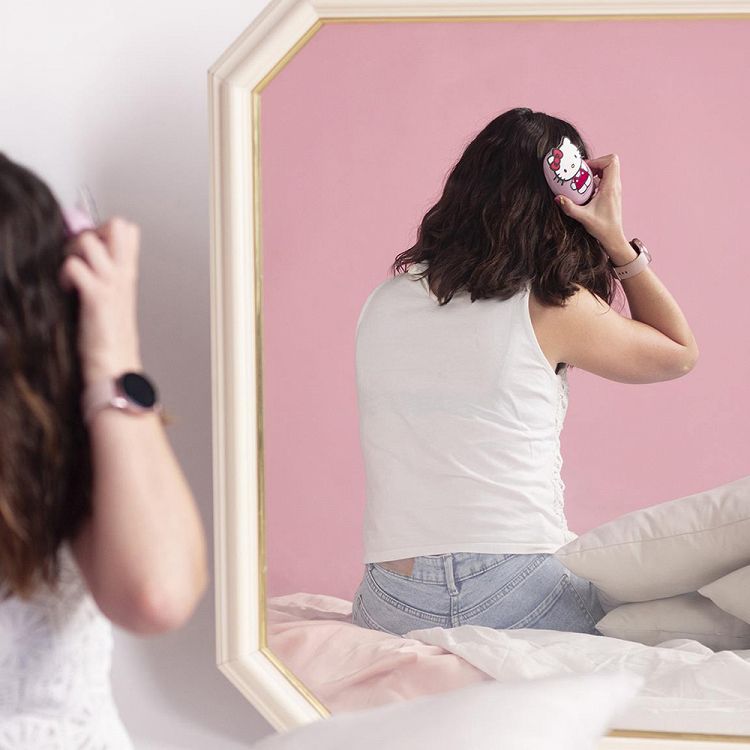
[555,154,627,252]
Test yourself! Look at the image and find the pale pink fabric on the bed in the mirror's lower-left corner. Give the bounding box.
[267,593,493,713]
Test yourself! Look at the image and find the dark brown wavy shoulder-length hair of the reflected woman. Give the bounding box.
[390,107,618,324]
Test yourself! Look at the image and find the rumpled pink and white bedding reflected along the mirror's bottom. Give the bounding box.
[267,593,750,735]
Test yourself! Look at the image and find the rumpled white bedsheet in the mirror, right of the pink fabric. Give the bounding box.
[405,625,750,735]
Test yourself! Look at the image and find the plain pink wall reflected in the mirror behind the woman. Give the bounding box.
[261,19,750,598]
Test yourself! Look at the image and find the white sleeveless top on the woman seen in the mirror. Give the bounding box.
[356,263,576,563]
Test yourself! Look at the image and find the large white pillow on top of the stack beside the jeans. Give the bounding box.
[555,476,750,603]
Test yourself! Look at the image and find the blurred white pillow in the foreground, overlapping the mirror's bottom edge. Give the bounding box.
[252,671,644,750]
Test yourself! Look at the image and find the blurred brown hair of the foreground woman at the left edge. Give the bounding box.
[0,153,91,597]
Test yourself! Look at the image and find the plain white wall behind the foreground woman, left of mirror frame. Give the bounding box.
[0,0,273,750]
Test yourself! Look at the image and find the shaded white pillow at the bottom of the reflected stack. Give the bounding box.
[596,591,750,651]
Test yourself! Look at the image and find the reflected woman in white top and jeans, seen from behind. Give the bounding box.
[353,107,698,635]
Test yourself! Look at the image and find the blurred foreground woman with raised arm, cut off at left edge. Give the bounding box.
[0,154,207,750]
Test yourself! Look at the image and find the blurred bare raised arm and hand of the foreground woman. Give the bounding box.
[60,218,207,634]
